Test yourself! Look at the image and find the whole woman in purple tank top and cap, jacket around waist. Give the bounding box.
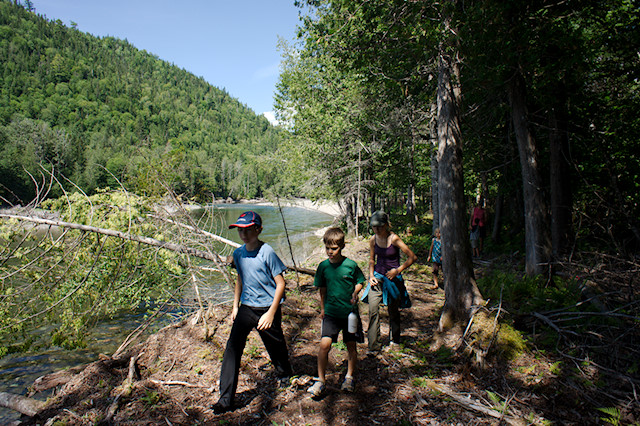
[363,210,417,355]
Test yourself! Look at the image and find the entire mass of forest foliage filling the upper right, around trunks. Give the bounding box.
[288,0,640,254]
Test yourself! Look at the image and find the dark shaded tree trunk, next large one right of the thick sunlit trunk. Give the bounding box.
[509,74,551,276]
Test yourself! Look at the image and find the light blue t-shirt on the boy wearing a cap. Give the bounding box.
[233,243,287,308]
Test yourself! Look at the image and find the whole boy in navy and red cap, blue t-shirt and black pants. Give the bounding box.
[211,211,292,413]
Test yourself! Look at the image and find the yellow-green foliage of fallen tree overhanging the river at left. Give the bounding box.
[0,191,183,353]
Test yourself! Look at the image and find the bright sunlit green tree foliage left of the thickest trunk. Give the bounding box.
[276,2,430,213]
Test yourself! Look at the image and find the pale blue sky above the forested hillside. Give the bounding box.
[33,0,299,124]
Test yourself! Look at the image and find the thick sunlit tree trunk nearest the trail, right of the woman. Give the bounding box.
[437,19,482,331]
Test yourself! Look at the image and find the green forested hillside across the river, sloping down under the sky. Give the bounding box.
[0,0,281,204]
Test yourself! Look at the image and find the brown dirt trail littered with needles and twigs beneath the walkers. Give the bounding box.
[16,241,636,425]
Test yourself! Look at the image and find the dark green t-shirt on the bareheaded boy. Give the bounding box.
[313,257,366,318]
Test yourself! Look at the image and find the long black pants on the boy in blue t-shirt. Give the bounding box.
[218,305,292,406]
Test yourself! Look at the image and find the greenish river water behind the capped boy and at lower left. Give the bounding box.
[0,204,334,424]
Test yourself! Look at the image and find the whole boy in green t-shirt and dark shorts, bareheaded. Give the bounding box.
[308,228,366,397]
